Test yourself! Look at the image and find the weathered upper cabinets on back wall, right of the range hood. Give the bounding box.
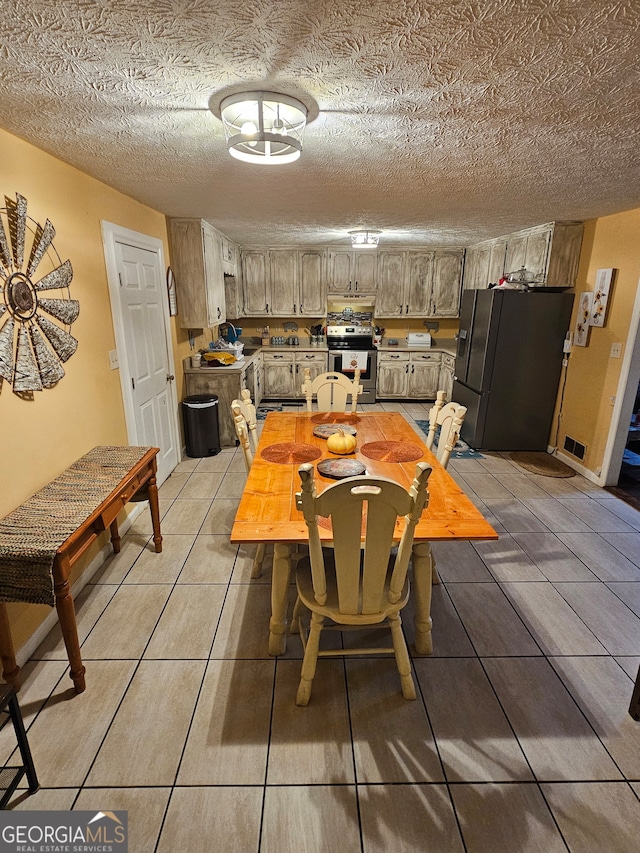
[376,249,463,318]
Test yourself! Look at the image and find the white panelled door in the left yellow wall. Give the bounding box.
[103,223,178,484]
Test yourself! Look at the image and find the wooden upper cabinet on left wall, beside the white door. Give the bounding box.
[169,219,226,329]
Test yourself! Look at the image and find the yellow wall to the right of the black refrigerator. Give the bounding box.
[557,208,640,474]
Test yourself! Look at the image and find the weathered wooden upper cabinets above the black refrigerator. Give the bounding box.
[464,222,583,289]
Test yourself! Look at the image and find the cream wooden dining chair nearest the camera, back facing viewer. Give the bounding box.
[293,462,431,705]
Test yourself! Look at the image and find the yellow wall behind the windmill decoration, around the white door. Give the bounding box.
[0,130,175,648]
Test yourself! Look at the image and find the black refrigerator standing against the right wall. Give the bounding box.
[452,288,573,451]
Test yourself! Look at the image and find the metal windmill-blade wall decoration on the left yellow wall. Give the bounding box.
[0,193,80,395]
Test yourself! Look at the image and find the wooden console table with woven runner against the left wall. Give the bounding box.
[0,447,162,693]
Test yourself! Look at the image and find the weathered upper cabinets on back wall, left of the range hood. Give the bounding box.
[242,249,327,317]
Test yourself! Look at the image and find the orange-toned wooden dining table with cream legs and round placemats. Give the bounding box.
[231,411,498,655]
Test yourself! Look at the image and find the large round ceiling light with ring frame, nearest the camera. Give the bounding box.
[220,92,307,164]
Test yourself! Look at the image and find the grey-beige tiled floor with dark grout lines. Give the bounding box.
[0,404,640,853]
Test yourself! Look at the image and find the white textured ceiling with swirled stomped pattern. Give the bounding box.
[0,0,640,246]
